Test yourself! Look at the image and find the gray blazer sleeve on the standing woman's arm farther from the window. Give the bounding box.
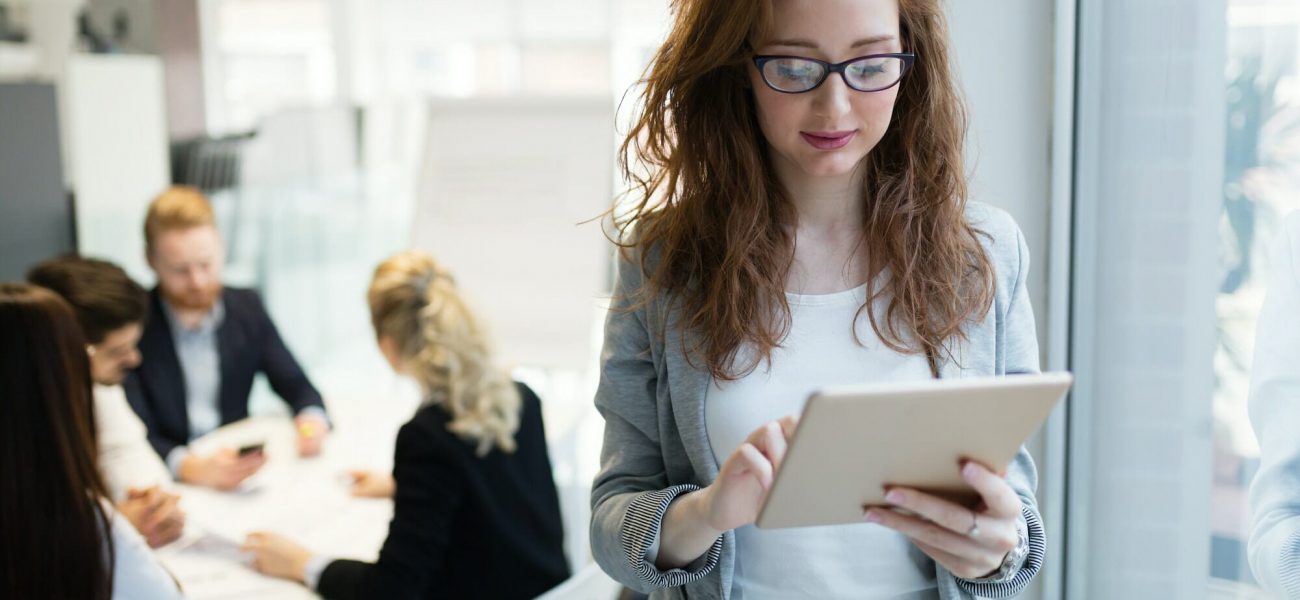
[590,250,723,594]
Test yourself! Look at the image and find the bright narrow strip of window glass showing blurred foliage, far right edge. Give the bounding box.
[1210,0,1300,590]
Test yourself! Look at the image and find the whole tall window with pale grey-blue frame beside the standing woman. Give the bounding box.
[1066,0,1300,599]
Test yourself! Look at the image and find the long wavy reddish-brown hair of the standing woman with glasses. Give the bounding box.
[614,0,993,379]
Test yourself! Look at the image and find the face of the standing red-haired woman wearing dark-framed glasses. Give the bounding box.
[749,0,902,177]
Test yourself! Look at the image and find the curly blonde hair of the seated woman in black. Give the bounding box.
[368,251,521,456]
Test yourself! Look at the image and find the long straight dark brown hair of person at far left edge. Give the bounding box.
[0,283,113,600]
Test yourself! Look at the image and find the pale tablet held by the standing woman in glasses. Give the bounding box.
[757,373,1074,529]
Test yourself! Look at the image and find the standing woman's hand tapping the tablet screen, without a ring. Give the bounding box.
[705,417,798,531]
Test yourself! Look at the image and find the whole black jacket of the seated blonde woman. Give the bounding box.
[316,383,569,600]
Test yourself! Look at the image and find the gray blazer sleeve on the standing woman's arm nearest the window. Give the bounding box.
[957,213,1047,597]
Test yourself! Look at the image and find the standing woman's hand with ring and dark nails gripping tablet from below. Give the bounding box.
[866,461,1021,579]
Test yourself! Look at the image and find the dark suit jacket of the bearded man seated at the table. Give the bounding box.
[122,287,325,458]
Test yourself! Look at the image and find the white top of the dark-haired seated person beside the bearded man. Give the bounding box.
[95,384,172,501]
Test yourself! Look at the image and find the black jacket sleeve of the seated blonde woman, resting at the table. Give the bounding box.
[316,423,467,600]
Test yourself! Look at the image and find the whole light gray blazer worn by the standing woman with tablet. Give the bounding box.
[592,203,1045,600]
